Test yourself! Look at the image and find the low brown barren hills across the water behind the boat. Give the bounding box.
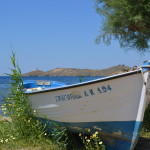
[23,65,132,76]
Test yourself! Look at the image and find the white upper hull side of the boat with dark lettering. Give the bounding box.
[30,74,145,122]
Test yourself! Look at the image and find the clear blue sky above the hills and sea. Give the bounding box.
[0,0,150,75]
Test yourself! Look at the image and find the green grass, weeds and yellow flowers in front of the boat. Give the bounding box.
[0,53,105,150]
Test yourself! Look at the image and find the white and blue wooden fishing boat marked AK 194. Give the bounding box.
[25,62,150,150]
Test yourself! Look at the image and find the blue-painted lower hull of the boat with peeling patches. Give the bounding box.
[39,118,142,150]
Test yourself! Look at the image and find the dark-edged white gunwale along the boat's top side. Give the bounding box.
[25,69,142,95]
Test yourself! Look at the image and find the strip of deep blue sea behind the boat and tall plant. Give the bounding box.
[0,76,100,115]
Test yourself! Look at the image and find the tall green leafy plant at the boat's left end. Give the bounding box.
[2,52,45,139]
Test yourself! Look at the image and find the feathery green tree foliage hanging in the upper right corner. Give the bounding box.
[96,0,150,52]
